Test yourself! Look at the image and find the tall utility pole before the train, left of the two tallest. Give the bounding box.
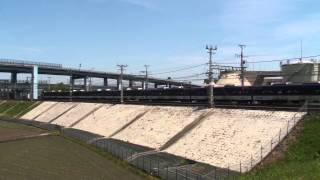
[206,45,218,107]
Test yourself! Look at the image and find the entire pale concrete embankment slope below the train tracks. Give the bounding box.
[22,102,304,171]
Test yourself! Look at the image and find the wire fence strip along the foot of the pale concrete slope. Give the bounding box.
[61,128,235,180]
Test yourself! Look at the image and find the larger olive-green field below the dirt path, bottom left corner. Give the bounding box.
[0,136,147,180]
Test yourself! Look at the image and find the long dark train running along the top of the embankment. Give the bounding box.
[42,84,320,104]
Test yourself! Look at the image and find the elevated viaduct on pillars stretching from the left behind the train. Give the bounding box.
[0,59,199,99]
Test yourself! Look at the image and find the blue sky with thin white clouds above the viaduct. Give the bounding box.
[0,0,320,83]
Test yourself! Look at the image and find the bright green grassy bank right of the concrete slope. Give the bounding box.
[243,114,320,180]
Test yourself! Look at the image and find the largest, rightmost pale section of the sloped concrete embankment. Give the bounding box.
[166,109,303,171]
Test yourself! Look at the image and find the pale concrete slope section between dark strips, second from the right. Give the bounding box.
[114,107,203,149]
